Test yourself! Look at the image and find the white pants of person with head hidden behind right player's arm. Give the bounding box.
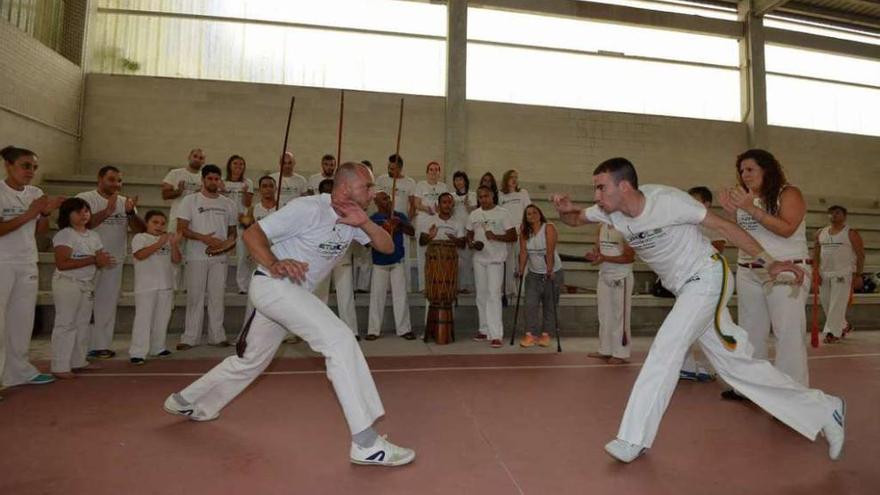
[596,272,633,359]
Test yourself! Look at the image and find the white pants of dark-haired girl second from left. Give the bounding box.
[52,273,95,373]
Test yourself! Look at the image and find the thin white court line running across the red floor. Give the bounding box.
[77,353,880,378]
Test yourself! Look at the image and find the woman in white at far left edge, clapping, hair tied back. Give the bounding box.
[0,146,63,389]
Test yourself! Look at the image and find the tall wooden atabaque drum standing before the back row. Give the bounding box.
[425,241,458,344]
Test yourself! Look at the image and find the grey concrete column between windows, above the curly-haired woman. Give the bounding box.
[738,0,769,148]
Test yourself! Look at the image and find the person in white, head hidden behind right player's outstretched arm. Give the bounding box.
[587,224,635,364]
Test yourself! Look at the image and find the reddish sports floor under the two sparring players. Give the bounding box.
[0,338,880,495]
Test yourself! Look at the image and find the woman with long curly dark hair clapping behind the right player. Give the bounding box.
[721,149,810,399]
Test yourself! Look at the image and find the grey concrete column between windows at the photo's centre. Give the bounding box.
[443,0,467,182]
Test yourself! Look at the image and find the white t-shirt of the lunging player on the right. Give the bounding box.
[584,185,715,294]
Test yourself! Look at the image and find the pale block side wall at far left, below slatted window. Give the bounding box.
[0,21,83,180]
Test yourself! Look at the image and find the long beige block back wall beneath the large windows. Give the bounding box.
[82,74,880,203]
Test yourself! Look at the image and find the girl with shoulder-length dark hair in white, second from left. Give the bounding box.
[52,198,118,378]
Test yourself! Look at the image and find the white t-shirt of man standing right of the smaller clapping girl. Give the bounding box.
[177,193,238,260]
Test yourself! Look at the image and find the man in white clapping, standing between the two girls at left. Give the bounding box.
[76,165,147,359]
